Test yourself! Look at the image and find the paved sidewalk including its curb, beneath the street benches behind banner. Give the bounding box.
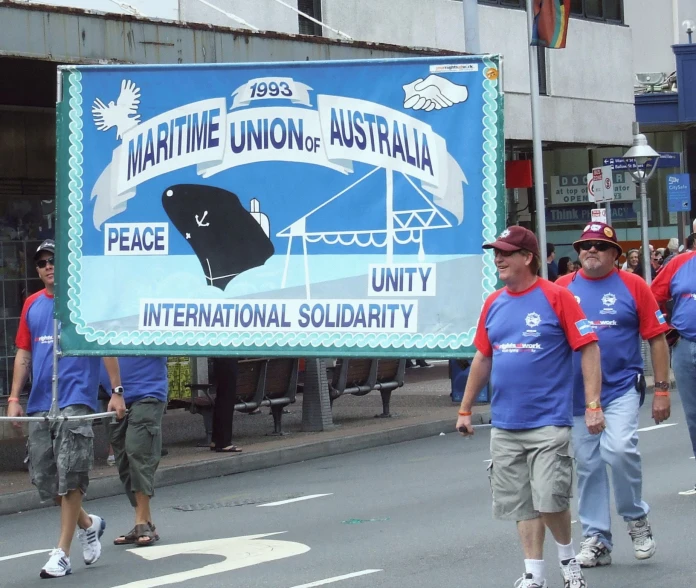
[0,362,490,514]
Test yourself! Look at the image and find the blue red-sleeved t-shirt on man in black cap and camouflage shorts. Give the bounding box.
[15,290,101,415]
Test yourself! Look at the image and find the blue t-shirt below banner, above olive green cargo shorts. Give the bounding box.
[100,357,169,406]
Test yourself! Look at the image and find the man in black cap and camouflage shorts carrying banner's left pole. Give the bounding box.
[7,239,125,578]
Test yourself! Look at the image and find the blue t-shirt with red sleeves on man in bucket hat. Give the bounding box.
[556,270,669,416]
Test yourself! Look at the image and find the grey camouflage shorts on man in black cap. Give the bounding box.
[27,405,94,501]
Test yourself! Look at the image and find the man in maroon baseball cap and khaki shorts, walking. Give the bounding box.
[457,226,604,588]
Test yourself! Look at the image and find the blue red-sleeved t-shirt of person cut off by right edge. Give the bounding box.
[652,251,696,341]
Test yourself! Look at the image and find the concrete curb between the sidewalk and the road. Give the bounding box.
[0,407,490,515]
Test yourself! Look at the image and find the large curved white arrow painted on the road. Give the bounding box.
[114,533,309,588]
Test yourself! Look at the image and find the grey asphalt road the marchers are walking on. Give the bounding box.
[0,397,696,588]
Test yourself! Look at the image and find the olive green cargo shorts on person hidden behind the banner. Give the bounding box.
[109,398,165,506]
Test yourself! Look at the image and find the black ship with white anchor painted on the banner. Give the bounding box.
[162,184,275,290]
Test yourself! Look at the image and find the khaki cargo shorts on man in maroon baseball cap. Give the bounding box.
[488,427,573,521]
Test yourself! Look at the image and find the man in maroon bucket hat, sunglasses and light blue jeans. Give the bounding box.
[557,223,670,568]
